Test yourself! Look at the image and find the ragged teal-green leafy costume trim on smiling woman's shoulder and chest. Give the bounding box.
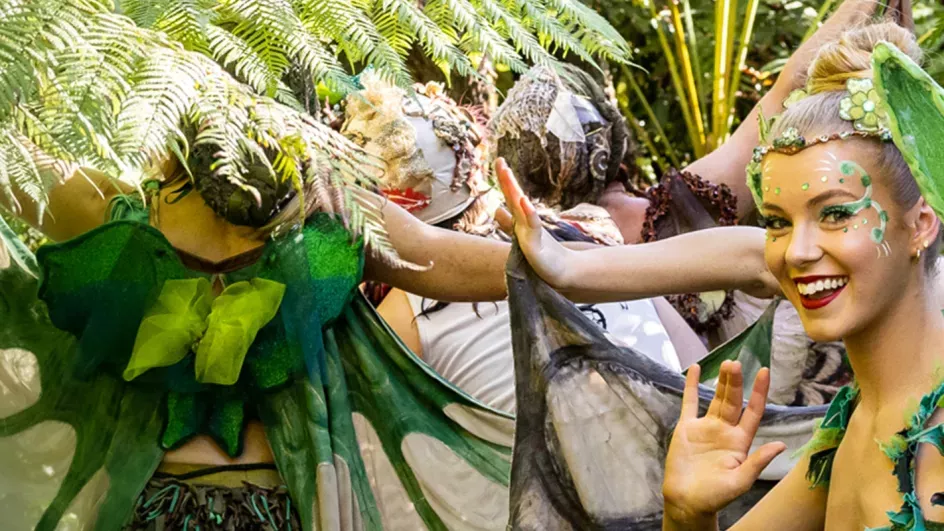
[806,383,944,531]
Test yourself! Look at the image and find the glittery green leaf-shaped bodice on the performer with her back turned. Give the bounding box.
[37,214,363,455]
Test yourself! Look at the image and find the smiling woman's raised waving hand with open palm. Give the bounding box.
[662,361,786,521]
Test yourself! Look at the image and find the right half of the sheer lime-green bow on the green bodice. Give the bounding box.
[196,278,285,385]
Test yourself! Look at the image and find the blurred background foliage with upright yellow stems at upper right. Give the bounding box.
[591,0,944,183]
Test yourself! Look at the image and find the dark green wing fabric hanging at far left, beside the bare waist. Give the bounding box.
[0,218,163,531]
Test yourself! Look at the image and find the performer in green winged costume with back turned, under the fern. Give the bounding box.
[0,80,513,530]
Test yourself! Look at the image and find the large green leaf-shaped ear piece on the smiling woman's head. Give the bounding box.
[872,42,944,222]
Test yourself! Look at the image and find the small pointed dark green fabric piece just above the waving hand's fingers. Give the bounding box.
[698,298,781,389]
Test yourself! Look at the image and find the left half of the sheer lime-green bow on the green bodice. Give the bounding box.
[122,278,213,381]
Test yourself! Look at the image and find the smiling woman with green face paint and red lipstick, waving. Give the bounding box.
[663,24,944,530]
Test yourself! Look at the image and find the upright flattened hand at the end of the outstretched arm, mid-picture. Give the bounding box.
[495,158,572,289]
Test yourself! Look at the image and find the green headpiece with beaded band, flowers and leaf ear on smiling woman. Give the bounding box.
[747,42,944,219]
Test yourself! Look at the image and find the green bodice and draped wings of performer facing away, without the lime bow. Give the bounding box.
[0,214,514,531]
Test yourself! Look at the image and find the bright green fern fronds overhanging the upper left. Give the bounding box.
[0,0,629,256]
